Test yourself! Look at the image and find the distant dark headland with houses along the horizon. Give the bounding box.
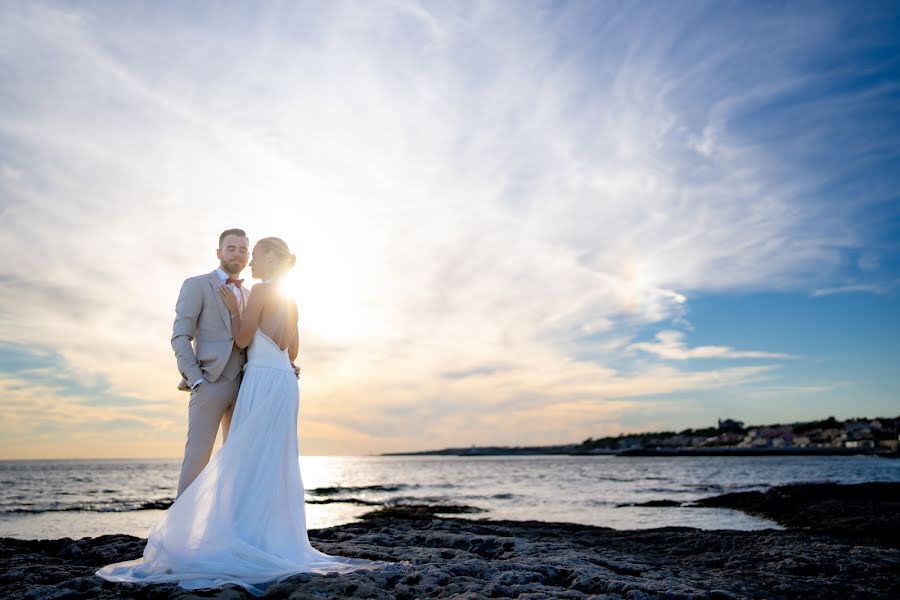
[379,416,900,458]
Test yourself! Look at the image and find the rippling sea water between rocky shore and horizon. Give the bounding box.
[0,456,900,539]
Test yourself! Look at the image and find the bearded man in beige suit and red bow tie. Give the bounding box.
[172,229,250,497]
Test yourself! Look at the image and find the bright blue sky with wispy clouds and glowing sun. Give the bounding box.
[0,0,900,459]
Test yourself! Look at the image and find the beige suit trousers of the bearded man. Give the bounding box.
[176,375,241,498]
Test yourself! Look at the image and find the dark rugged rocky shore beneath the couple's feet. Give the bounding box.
[0,484,900,600]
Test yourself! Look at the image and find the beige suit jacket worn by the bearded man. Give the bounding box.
[172,271,250,390]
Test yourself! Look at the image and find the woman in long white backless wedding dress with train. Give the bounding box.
[97,237,396,595]
